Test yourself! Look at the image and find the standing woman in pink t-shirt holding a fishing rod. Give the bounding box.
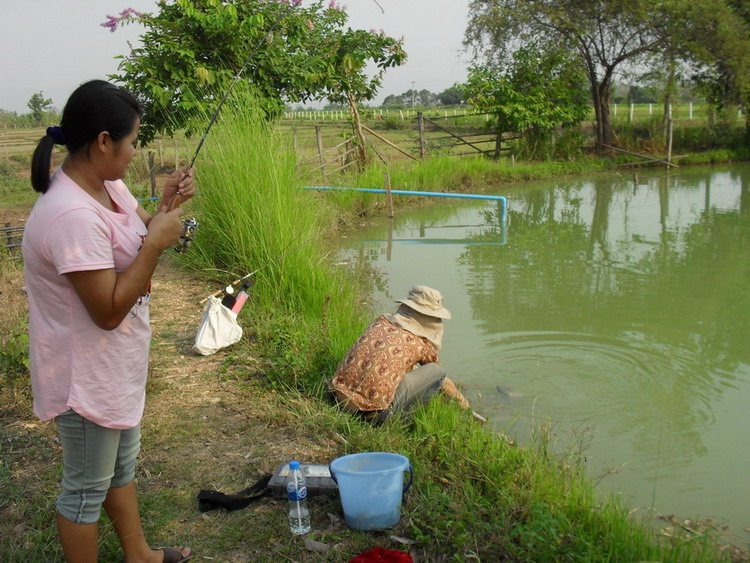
[23,80,195,562]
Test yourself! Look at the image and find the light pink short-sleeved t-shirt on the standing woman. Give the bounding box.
[23,168,151,429]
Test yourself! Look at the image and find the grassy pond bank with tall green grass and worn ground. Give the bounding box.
[0,113,748,561]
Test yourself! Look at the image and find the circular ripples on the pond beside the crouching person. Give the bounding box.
[477,332,731,456]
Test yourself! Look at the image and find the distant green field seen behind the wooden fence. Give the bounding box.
[0,104,744,181]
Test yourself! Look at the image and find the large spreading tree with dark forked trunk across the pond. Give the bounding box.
[464,0,677,146]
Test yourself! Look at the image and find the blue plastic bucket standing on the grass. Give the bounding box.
[330,452,414,530]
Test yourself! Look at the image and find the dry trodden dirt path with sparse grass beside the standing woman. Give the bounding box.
[139,258,340,562]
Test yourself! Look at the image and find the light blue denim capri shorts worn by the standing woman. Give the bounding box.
[55,410,141,524]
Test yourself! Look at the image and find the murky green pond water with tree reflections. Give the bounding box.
[342,165,750,542]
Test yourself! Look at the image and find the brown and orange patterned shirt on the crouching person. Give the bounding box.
[329,315,438,411]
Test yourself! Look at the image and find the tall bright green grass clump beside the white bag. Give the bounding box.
[178,97,364,386]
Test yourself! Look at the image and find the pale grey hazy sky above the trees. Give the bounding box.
[0,0,469,114]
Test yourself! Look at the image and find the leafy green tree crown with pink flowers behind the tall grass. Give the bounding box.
[102,0,406,143]
